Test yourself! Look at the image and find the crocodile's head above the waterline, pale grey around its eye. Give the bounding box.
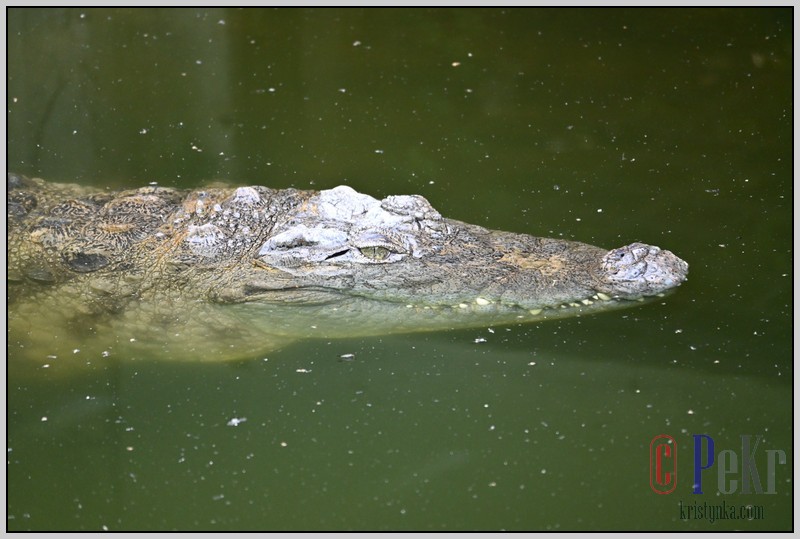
[223,186,688,317]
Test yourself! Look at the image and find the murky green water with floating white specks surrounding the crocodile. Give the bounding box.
[7,9,794,531]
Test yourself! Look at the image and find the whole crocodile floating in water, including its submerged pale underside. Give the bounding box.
[7,173,688,374]
